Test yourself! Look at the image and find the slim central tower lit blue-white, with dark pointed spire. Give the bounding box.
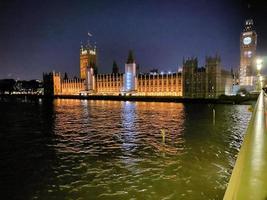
[123,51,136,93]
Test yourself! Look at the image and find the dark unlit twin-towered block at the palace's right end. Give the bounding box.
[183,56,233,98]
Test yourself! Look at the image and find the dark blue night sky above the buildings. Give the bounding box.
[0,0,267,79]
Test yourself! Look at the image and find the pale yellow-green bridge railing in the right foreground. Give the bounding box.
[224,91,267,200]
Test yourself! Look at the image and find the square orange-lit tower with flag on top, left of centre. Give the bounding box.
[80,43,97,79]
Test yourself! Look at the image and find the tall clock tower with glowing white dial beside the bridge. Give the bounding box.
[239,19,257,88]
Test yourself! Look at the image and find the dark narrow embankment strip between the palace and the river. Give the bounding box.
[0,94,258,104]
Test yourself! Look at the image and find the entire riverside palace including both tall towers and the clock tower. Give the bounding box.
[43,20,264,98]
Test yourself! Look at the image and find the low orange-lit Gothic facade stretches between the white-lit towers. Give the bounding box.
[43,72,183,96]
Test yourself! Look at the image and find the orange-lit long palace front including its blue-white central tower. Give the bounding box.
[43,52,183,96]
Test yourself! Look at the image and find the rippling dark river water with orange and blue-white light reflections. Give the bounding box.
[0,100,251,200]
